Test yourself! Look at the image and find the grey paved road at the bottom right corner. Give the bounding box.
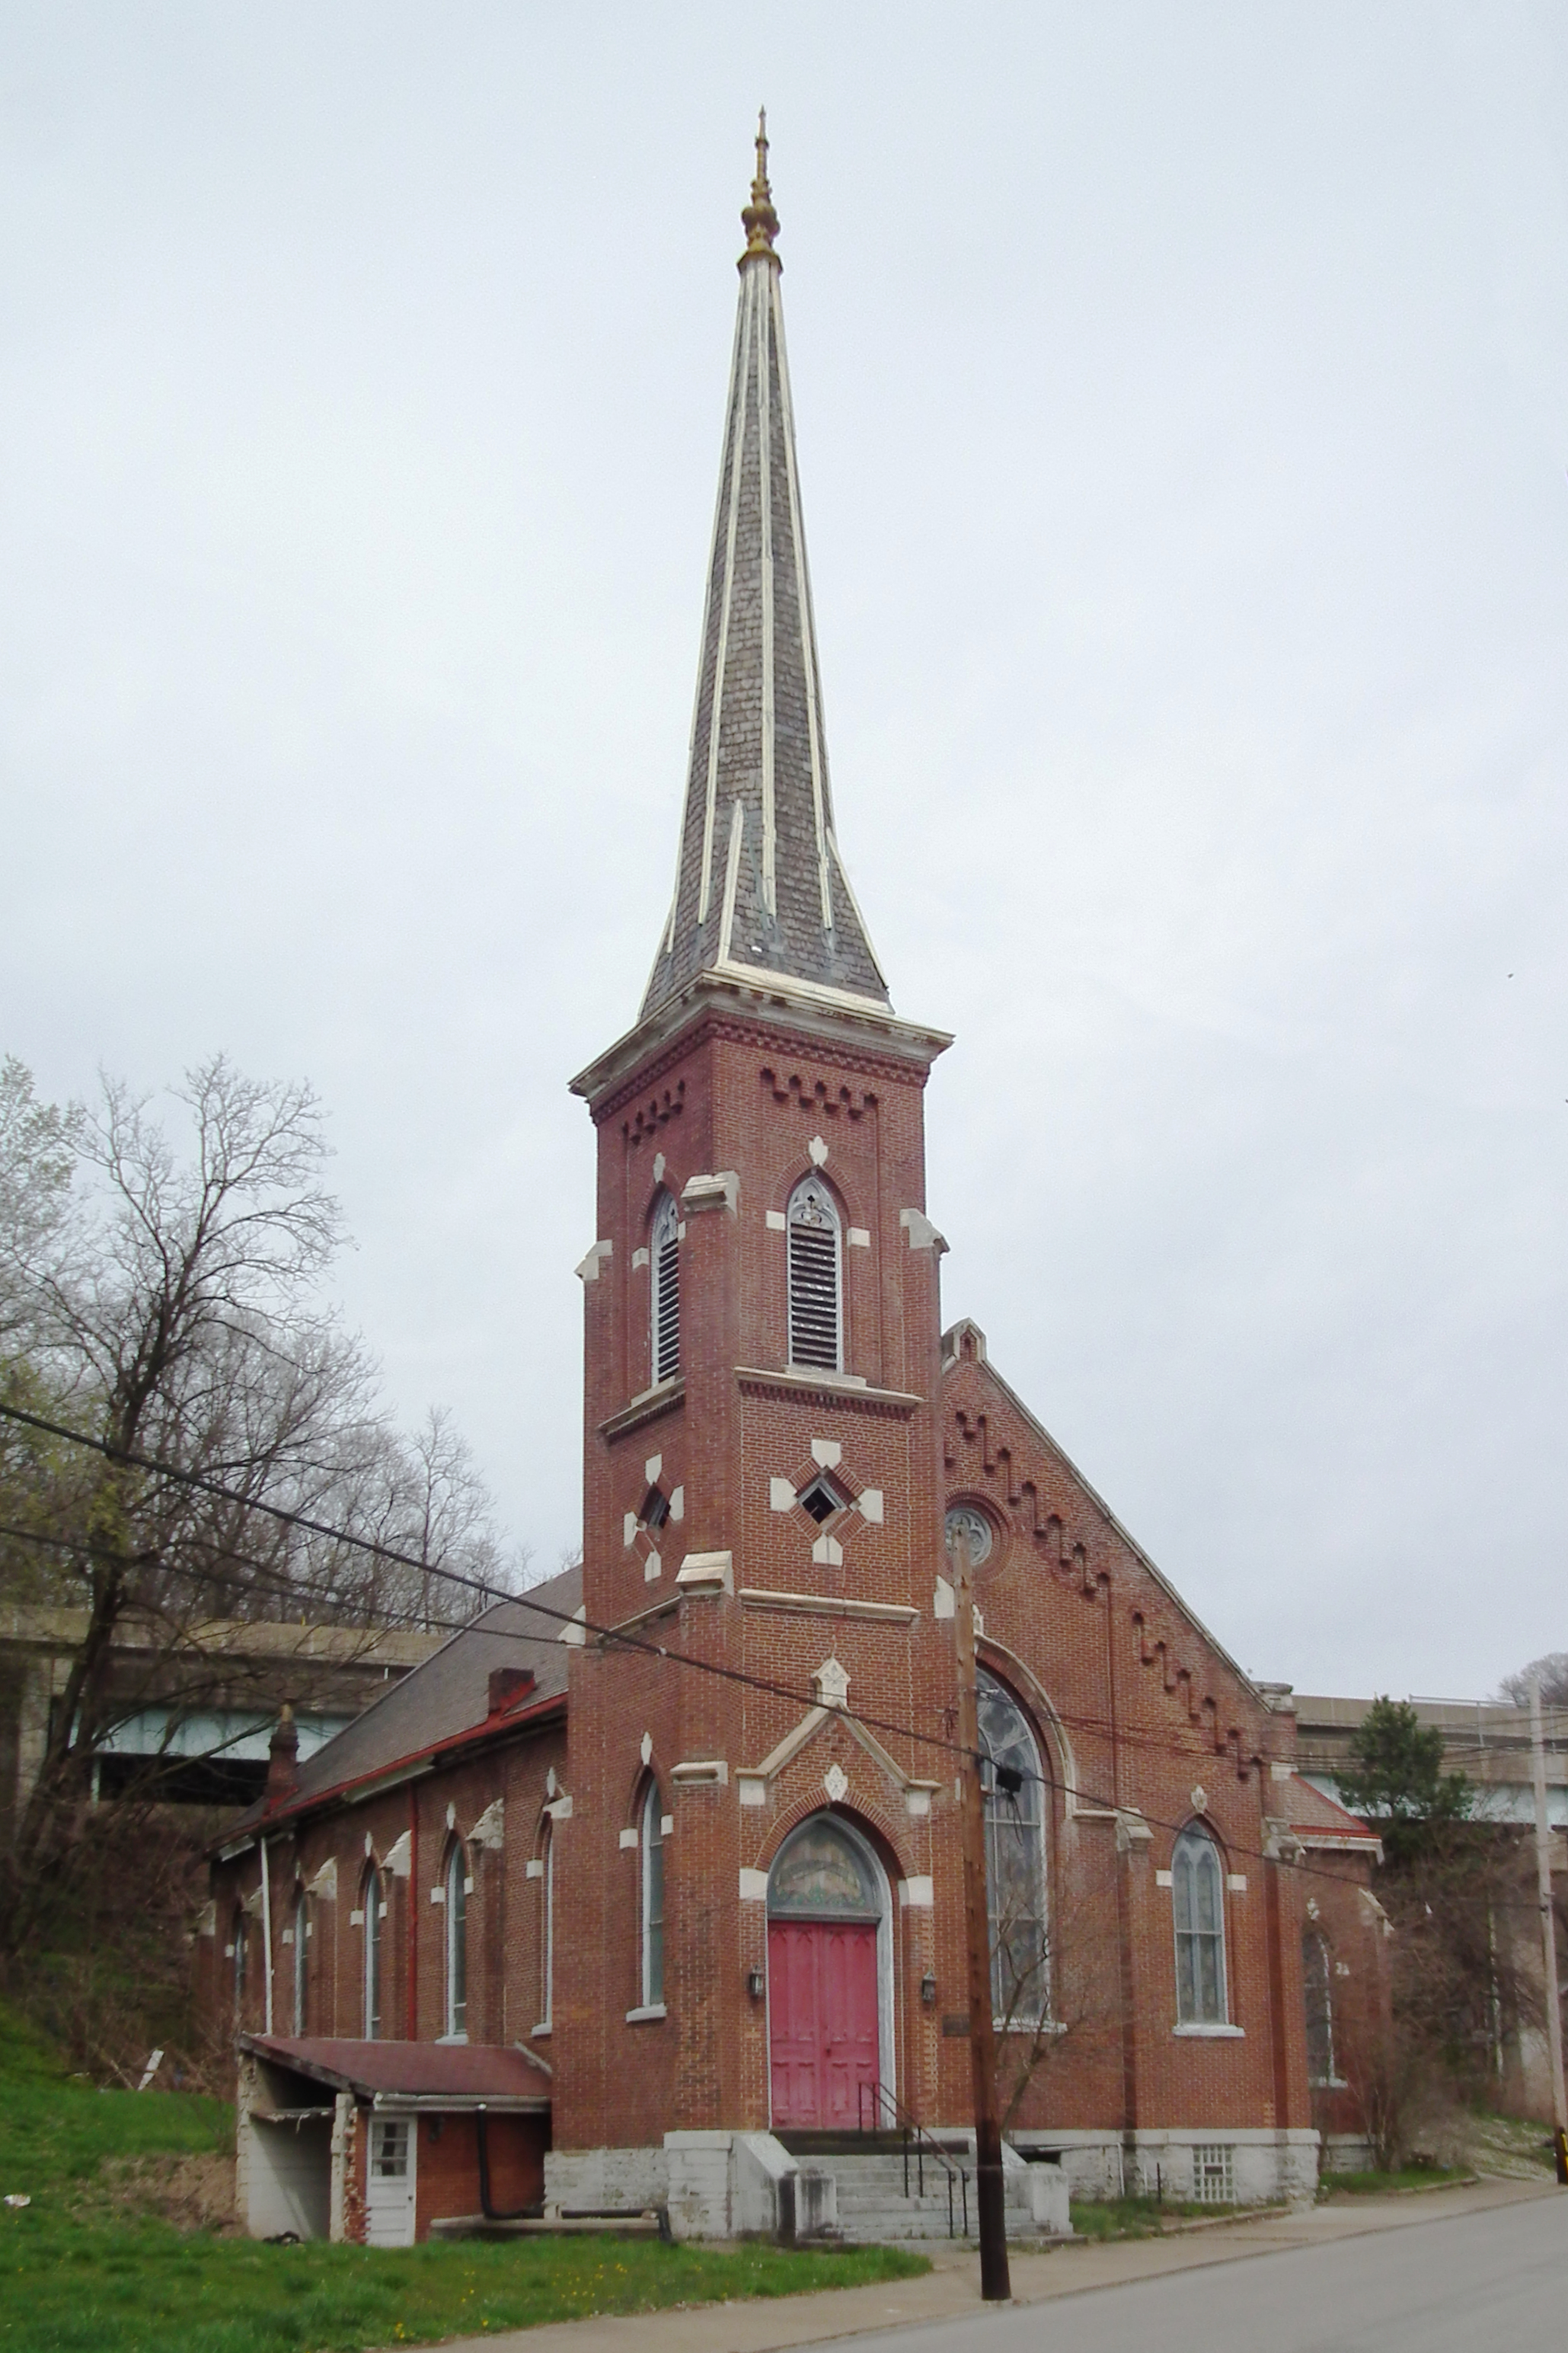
[832,2198,1568,2353]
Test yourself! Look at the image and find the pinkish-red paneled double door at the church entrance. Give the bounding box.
[768,1920,882,2132]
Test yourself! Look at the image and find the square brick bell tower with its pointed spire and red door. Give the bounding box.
[550,127,964,2150]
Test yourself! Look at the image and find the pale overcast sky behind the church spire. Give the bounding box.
[0,0,1568,1694]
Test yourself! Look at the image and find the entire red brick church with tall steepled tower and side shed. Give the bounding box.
[197,141,1384,2243]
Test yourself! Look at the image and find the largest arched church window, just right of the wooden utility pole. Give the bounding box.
[978,1668,1051,2026]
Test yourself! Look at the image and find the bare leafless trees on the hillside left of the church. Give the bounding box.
[0,1057,508,1951]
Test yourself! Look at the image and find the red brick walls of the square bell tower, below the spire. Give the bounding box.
[555,1019,950,2148]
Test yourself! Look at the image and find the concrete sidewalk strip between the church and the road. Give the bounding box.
[425,2179,1559,2353]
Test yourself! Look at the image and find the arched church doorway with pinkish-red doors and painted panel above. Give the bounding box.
[768,1814,891,2132]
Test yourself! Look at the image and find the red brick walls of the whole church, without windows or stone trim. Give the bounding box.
[202,988,1375,2163]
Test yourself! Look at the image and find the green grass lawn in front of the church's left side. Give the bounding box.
[0,2014,928,2353]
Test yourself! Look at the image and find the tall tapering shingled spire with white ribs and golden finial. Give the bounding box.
[642,113,889,1016]
